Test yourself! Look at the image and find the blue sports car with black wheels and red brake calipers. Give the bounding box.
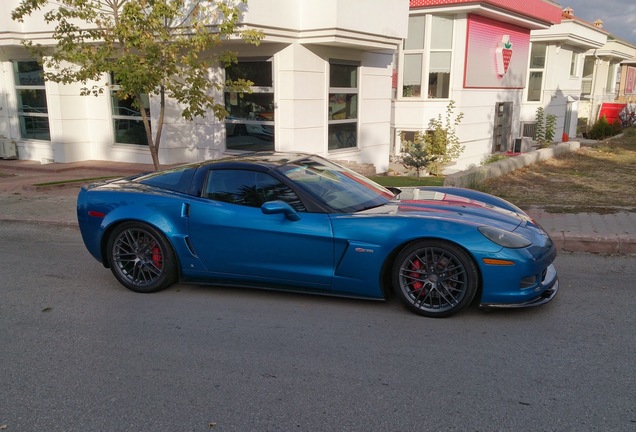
[77,153,558,317]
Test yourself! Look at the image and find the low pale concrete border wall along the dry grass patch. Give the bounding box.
[444,141,581,187]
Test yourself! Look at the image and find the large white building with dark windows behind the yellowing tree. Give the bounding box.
[0,0,409,171]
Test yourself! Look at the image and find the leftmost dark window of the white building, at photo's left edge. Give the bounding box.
[13,61,51,141]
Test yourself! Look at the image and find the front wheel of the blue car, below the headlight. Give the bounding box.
[392,240,479,318]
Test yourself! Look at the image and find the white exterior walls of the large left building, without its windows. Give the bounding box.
[0,0,402,171]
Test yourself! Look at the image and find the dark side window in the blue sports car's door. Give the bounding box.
[204,169,306,212]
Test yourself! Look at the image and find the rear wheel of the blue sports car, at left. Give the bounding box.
[107,222,178,293]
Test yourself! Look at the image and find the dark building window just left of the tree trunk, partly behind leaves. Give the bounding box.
[110,73,150,146]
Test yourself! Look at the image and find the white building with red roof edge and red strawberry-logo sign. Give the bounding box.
[394,0,561,172]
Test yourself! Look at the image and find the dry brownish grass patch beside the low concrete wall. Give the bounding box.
[483,128,636,213]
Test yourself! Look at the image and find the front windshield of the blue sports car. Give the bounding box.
[279,156,393,213]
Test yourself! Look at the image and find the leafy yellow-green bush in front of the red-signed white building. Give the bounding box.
[400,101,465,178]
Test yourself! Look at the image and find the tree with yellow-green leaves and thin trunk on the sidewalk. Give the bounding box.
[11,0,262,169]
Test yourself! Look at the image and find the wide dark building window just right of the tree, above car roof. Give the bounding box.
[225,61,274,151]
